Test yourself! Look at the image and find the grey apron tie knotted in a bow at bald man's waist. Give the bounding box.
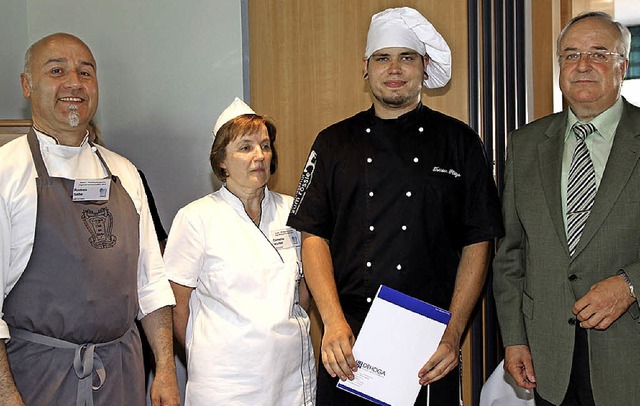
[9,325,127,406]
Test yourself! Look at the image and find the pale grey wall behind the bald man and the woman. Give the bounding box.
[0,0,248,230]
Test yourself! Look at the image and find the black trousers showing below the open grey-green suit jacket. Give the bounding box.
[534,325,595,406]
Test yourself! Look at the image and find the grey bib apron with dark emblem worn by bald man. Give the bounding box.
[3,129,145,406]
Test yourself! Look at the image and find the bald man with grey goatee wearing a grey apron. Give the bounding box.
[0,33,179,405]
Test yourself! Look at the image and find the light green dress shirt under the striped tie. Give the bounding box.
[560,97,623,232]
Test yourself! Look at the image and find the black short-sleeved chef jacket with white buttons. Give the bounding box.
[287,104,504,334]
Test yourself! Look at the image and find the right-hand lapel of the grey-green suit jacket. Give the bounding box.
[574,101,640,258]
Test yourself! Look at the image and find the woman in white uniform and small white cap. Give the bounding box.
[164,98,316,406]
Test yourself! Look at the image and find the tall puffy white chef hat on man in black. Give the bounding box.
[365,7,451,88]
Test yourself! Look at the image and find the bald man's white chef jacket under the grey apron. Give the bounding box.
[0,131,175,339]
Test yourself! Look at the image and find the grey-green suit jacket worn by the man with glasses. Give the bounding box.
[493,100,640,406]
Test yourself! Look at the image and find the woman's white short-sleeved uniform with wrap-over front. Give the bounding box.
[164,187,315,406]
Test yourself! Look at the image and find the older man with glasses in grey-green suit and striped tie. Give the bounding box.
[494,12,640,406]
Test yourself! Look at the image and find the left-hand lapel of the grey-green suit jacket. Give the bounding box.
[538,111,569,255]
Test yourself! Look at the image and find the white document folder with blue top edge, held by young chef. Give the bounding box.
[338,285,451,406]
